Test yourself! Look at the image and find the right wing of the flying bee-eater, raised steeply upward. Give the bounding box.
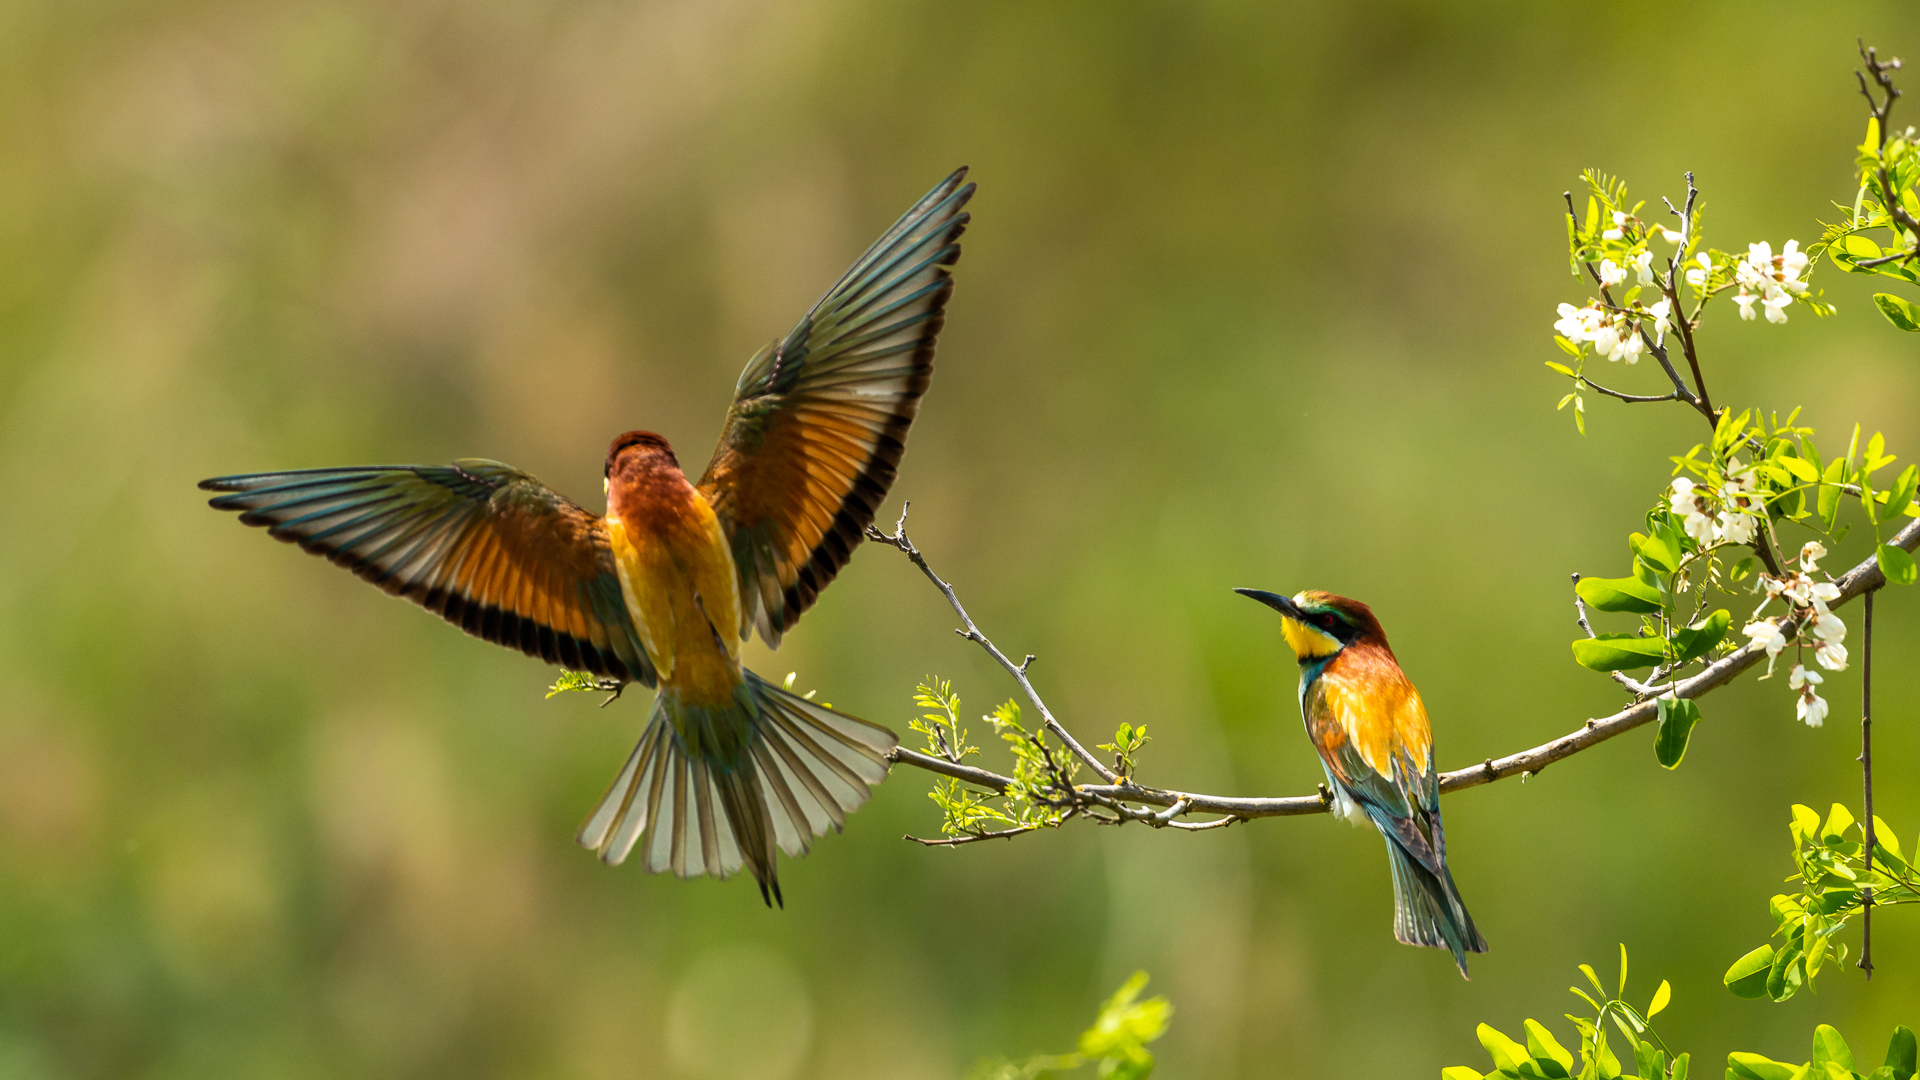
[701,169,973,646]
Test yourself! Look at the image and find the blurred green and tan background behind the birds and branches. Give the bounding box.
[0,0,1920,1080]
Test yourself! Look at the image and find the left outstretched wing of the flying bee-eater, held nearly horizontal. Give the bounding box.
[200,457,655,686]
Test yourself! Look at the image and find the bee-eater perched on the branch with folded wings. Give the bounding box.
[1235,588,1486,978]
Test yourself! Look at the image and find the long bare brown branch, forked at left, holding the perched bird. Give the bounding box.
[870,509,1920,826]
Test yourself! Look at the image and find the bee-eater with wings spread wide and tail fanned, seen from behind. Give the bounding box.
[200,169,973,905]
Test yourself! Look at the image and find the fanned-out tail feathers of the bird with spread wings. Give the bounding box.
[580,671,899,905]
